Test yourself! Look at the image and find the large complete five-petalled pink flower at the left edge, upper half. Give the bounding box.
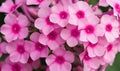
[1,14,29,42]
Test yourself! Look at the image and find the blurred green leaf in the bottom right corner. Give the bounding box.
[106,53,120,71]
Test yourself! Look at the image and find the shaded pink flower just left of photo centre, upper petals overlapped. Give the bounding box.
[39,29,64,50]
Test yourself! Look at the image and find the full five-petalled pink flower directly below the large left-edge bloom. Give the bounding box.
[6,40,33,63]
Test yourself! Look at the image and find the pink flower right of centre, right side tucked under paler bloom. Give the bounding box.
[60,25,80,47]
